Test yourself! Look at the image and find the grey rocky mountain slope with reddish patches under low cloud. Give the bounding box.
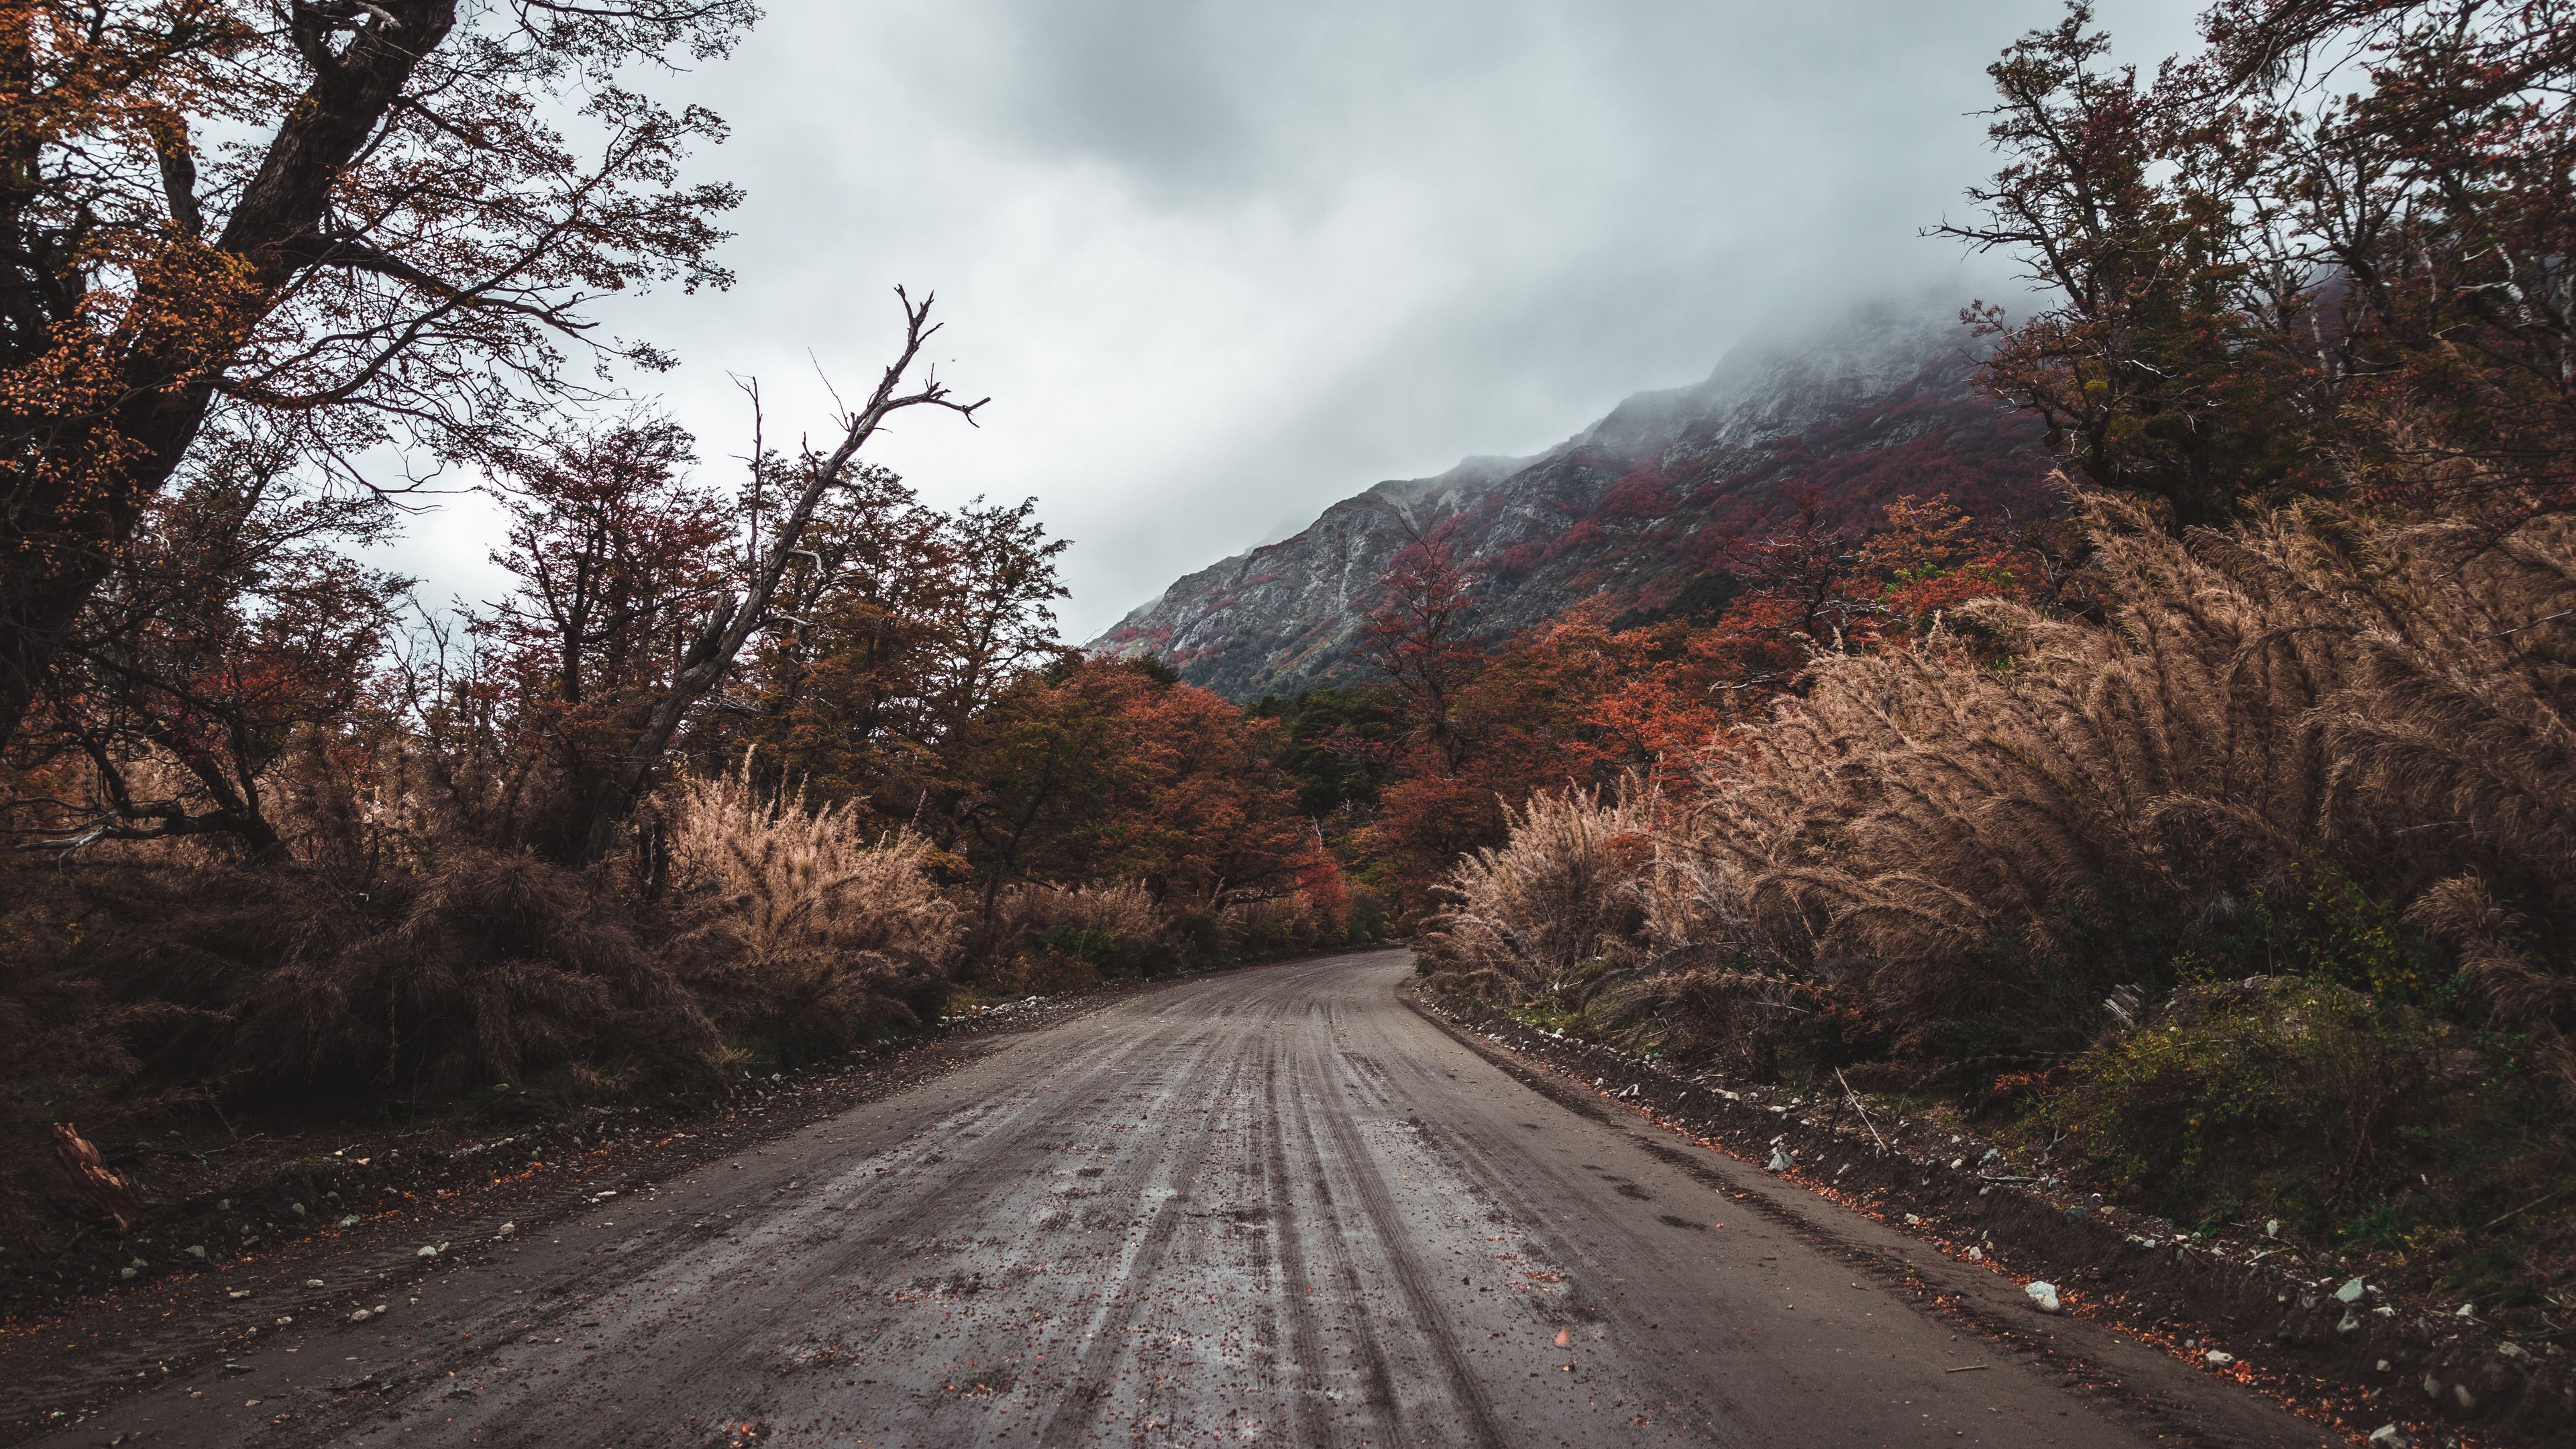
[1089,312,2061,699]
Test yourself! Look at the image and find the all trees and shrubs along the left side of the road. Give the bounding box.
[0,0,1376,1250]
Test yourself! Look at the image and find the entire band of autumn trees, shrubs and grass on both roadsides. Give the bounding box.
[0,0,2576,1336]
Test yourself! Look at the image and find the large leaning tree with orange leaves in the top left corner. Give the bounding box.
[0,0,755,743]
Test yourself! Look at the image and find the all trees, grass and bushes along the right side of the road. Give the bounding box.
[1389,0,2576,1343]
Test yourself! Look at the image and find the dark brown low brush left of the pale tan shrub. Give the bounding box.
[0,846,714,1122]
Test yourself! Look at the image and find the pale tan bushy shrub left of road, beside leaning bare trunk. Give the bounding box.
[667,758,961,1055]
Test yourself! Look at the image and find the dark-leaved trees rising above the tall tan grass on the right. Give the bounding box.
[1942,0,2576,526]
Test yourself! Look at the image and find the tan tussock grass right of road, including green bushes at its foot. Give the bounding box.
[1430,495,2576,1302]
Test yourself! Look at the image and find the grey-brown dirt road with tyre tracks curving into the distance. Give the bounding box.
[25,951,2331,1446]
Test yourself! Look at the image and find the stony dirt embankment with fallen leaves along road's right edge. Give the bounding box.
[1409,993,2576,1444]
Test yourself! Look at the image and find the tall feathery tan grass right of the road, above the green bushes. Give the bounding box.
[1440,495,2576,1085]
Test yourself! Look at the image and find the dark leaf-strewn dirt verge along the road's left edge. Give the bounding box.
[0,977,1198,1444]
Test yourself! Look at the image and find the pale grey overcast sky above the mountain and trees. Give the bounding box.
[381,0,2195,639]
